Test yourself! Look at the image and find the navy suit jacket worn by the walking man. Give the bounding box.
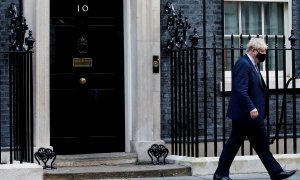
[227,54,267,124]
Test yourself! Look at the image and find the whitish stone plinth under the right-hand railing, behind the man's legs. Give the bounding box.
[167,154,300,176]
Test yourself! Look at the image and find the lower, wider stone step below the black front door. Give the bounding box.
[44,164,191,180]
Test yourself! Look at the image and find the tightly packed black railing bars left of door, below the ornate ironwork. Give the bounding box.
[9,52,33,163]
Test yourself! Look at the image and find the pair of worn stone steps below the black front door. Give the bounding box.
[44,153,191,180]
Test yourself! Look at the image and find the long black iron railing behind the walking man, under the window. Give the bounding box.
[169,31,300,157]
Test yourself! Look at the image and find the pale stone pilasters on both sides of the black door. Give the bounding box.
[24,0,163,161]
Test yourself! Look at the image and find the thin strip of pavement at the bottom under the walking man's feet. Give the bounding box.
[102,171,300,180]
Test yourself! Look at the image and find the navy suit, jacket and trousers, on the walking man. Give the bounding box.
[216,55,283,176]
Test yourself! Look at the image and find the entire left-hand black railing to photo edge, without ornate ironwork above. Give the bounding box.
[0,51,33,163]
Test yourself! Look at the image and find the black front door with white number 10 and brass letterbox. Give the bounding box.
[50,0,125,154]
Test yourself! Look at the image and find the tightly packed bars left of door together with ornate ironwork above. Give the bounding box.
[8,0,35,163]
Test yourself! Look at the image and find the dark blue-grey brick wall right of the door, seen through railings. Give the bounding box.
[161,0,300,141]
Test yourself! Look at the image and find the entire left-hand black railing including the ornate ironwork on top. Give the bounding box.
[0,0,35,163]
